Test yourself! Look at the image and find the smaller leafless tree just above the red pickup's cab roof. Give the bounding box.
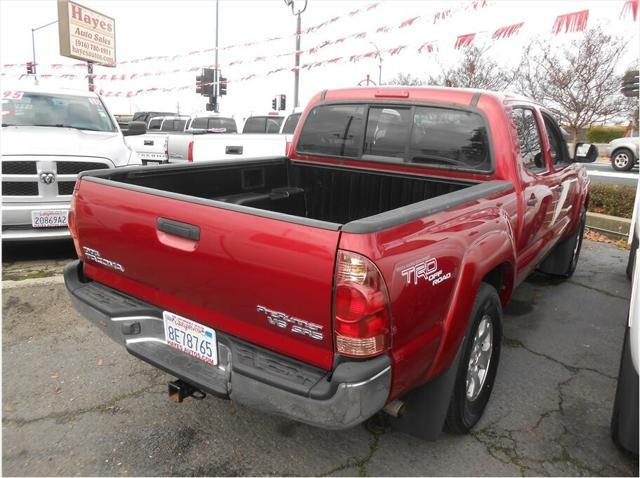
[429,45,514,91]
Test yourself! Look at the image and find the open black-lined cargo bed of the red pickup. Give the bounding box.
[80,158,492,229]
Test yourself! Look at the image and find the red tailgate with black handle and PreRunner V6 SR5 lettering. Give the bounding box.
[76,178,339,370]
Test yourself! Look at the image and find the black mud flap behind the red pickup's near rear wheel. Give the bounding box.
[391,340,465,441]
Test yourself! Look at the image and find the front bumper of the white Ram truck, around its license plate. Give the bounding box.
[2,202,71,241]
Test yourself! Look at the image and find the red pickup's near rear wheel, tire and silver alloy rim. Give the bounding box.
[445,282,502,433]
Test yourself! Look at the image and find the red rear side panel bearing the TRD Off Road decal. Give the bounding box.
[340,187,517,400]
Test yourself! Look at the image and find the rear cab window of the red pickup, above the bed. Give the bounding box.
[297,104,493,173]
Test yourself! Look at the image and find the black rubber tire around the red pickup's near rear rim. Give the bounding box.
[445,282,502,434]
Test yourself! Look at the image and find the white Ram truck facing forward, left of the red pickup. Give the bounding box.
[0,87,141,241]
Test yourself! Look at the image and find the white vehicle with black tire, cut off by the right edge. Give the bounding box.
[611,177,640,455]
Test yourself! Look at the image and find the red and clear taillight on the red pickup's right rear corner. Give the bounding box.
[333,251,391,358]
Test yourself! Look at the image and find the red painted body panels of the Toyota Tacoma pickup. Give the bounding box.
[75,88,588,400]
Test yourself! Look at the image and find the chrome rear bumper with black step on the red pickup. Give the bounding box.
[64,261,391,429]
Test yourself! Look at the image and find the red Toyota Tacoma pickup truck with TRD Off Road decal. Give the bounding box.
[65,88,597,438]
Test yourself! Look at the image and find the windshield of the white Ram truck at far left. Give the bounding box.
[2,91,116,131]
